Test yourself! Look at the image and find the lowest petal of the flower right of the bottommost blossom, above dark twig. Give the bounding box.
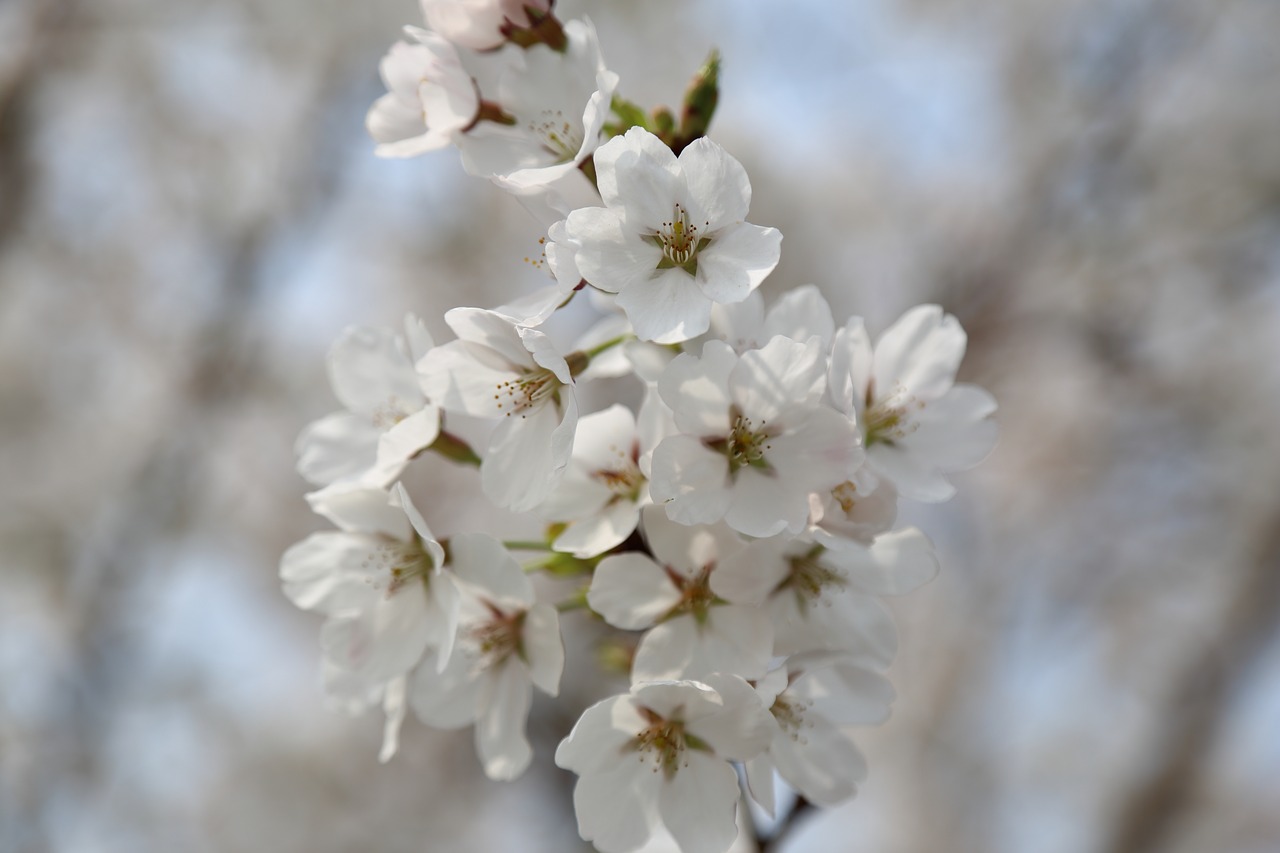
[769,715,867,806]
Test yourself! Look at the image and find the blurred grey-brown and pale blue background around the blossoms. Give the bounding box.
[0,0,1280,853]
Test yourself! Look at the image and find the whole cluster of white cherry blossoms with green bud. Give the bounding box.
[280,0,996,853]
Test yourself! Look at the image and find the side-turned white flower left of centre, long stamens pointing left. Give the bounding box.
[419,307,585,512]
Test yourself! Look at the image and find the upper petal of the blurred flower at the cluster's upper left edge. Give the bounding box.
[328,327,422,415]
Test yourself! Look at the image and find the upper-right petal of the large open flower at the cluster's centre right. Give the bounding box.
[728,337,827,429]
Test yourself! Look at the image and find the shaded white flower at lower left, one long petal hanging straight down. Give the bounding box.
[410,534,564,779]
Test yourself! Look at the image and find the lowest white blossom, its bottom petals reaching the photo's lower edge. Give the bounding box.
[556,676,773,853]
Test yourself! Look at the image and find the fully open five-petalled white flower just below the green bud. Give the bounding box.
[564,127,782,343]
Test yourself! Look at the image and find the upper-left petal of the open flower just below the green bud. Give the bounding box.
[595,127,685,225]
